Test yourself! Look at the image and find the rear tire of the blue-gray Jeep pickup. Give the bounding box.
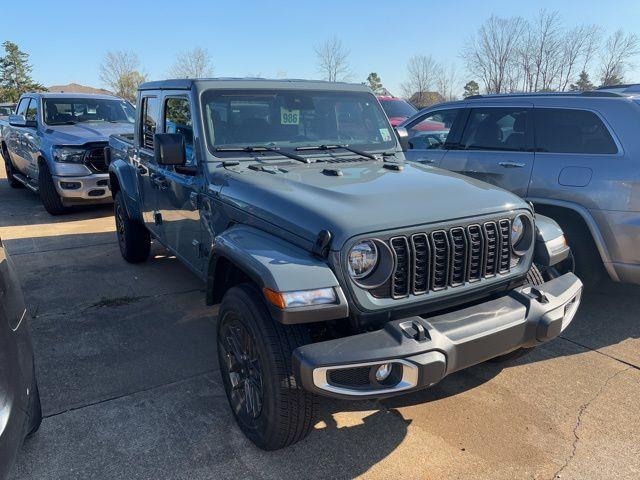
[113,191,151,263]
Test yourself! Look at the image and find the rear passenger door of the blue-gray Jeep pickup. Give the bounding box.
[133,92,162,236]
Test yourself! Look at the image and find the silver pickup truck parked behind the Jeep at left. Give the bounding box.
[0,93,135,215]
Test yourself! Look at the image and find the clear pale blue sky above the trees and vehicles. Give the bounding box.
[0,0,640,94]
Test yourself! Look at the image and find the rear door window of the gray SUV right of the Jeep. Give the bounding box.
[460,107,533,151]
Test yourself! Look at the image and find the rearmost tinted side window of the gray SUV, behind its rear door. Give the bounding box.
[535,108,618,154]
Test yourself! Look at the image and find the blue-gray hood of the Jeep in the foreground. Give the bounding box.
[213,161,529,249]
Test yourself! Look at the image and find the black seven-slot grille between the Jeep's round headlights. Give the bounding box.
[388,219,511,298]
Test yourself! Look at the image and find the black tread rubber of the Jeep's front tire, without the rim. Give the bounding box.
[218,284,317,450]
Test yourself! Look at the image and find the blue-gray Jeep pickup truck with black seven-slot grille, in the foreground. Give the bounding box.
[107,79,582,449]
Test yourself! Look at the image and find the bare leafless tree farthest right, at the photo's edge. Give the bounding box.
[600,30,640,86]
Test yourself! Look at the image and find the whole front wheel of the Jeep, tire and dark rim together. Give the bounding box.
[218,284,317,450]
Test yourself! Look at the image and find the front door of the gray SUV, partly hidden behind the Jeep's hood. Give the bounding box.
[405,107,464,167]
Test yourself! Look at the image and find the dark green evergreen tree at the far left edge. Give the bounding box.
[0,40,46,102]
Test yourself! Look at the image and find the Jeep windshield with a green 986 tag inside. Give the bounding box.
[202,90,396,155]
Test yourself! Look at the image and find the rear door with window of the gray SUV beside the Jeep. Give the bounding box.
[441,104,534,197]
